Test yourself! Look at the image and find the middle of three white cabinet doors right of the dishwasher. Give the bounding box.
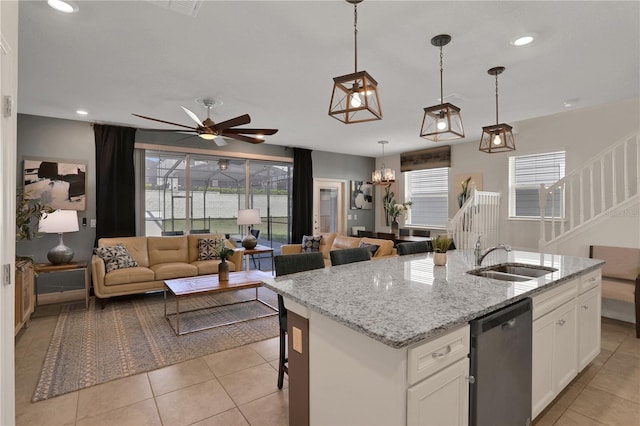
[553,299,578,395]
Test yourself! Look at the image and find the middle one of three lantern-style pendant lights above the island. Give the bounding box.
[420,34,464,142]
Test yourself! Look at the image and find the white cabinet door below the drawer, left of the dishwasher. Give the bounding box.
[407,358,469,426]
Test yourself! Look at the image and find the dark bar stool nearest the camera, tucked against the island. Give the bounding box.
[274,252,324,389]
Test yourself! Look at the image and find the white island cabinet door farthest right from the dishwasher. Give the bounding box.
[578,286,602,371]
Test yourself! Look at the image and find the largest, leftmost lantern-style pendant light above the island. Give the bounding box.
[329,0,382,124]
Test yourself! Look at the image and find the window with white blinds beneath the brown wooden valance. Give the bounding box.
[404,167,449,228]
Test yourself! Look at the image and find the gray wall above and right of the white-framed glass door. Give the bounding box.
[311,151,380,234]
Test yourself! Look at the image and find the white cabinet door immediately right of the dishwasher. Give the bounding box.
[531,313,556,419]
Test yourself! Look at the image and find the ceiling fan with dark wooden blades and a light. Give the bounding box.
[133,99,278,146]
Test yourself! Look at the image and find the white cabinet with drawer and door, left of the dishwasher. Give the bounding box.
[407,326,470,425]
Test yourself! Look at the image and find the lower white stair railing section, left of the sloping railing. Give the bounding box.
[447,189,500,249]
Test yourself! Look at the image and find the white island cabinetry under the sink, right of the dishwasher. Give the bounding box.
[531,270,600,418]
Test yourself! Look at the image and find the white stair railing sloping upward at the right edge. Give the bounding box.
[538,133,640,249]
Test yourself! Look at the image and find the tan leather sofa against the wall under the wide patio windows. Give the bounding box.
[91,234,243,307]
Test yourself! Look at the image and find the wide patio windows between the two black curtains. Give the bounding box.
[143,150,293,248]
